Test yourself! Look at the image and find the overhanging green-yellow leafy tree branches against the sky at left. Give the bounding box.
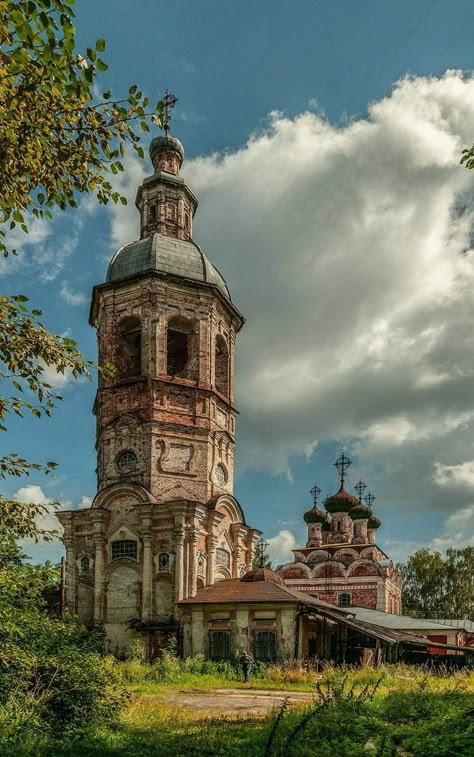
[0,0,163,538]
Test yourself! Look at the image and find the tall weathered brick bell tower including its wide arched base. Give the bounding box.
[58,103,260,655]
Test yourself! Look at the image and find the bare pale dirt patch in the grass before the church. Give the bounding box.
[144,689,313,715]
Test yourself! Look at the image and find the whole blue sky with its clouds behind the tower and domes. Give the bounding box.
[0,0,474,560]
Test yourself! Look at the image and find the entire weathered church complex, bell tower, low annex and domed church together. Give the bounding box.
[58,111,408,660]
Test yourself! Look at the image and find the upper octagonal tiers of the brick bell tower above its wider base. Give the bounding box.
[90,135,243,503]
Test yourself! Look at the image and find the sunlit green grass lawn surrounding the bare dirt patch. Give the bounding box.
[41,666,474,757]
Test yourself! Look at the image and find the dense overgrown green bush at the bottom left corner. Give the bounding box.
[0,564,124,755]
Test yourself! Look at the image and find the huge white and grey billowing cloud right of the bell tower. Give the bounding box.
[106,71,474,517]
